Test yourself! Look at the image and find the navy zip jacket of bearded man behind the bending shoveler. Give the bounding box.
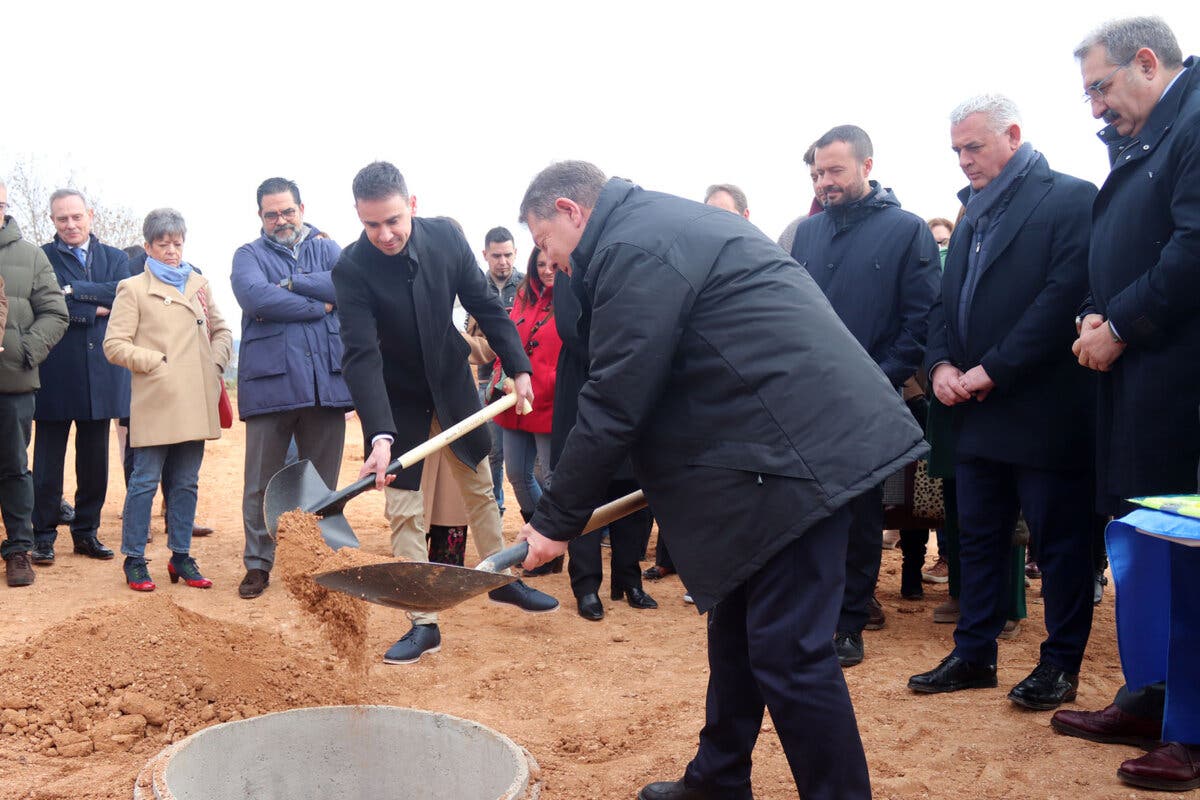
[792,181,941,386]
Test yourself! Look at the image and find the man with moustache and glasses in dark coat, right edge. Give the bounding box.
[1051,17,1200,790]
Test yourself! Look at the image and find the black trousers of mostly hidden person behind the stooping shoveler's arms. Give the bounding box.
[566,481,650,597]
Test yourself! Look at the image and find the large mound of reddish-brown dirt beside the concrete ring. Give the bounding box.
[0,595,359,757]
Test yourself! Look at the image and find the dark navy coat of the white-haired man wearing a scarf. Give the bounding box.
[926,156,1096,469]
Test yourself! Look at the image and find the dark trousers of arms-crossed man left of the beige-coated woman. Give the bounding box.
[34,420,112,545]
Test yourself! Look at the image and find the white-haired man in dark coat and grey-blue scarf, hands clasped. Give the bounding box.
[908,95,1096,709]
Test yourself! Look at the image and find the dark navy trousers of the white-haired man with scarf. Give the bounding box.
[954,459,1094,673]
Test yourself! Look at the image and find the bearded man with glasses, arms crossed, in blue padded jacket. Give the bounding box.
[232,178,353,600]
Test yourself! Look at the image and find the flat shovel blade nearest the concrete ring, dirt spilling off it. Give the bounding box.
[313,561,516,612]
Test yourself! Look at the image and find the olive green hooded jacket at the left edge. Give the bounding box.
[0,217,67,395]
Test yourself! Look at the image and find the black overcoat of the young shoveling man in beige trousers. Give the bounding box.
[334,217,529,489]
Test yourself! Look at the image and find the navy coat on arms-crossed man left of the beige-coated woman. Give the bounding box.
[34,236,130,421]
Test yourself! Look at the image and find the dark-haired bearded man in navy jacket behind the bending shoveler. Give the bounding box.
[791,125,941,667]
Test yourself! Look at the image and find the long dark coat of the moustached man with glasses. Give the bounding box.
[1084,56,1200,509]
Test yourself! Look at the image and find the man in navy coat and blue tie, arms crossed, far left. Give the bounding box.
[32,188,130,565]
